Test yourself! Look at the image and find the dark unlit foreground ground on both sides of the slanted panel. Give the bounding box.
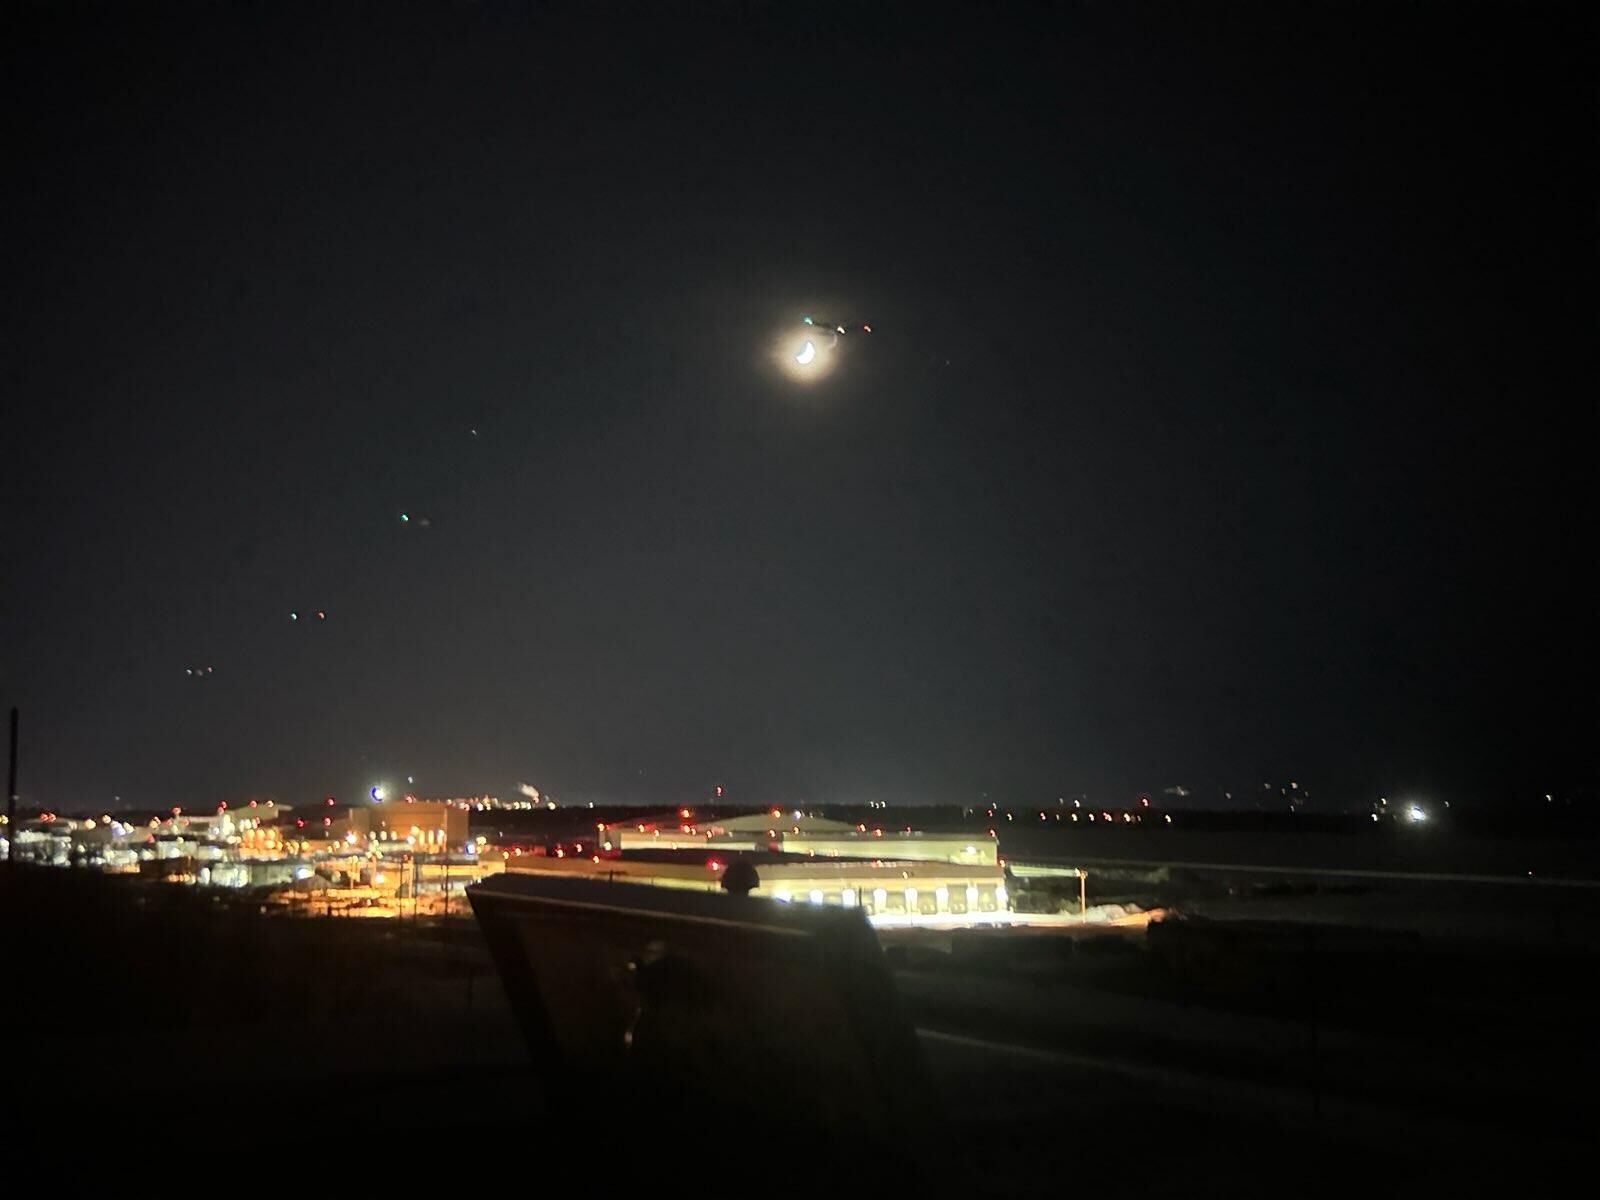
[0,872,1597,1195]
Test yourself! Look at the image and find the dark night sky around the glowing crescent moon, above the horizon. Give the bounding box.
[0,2,1600,808]
